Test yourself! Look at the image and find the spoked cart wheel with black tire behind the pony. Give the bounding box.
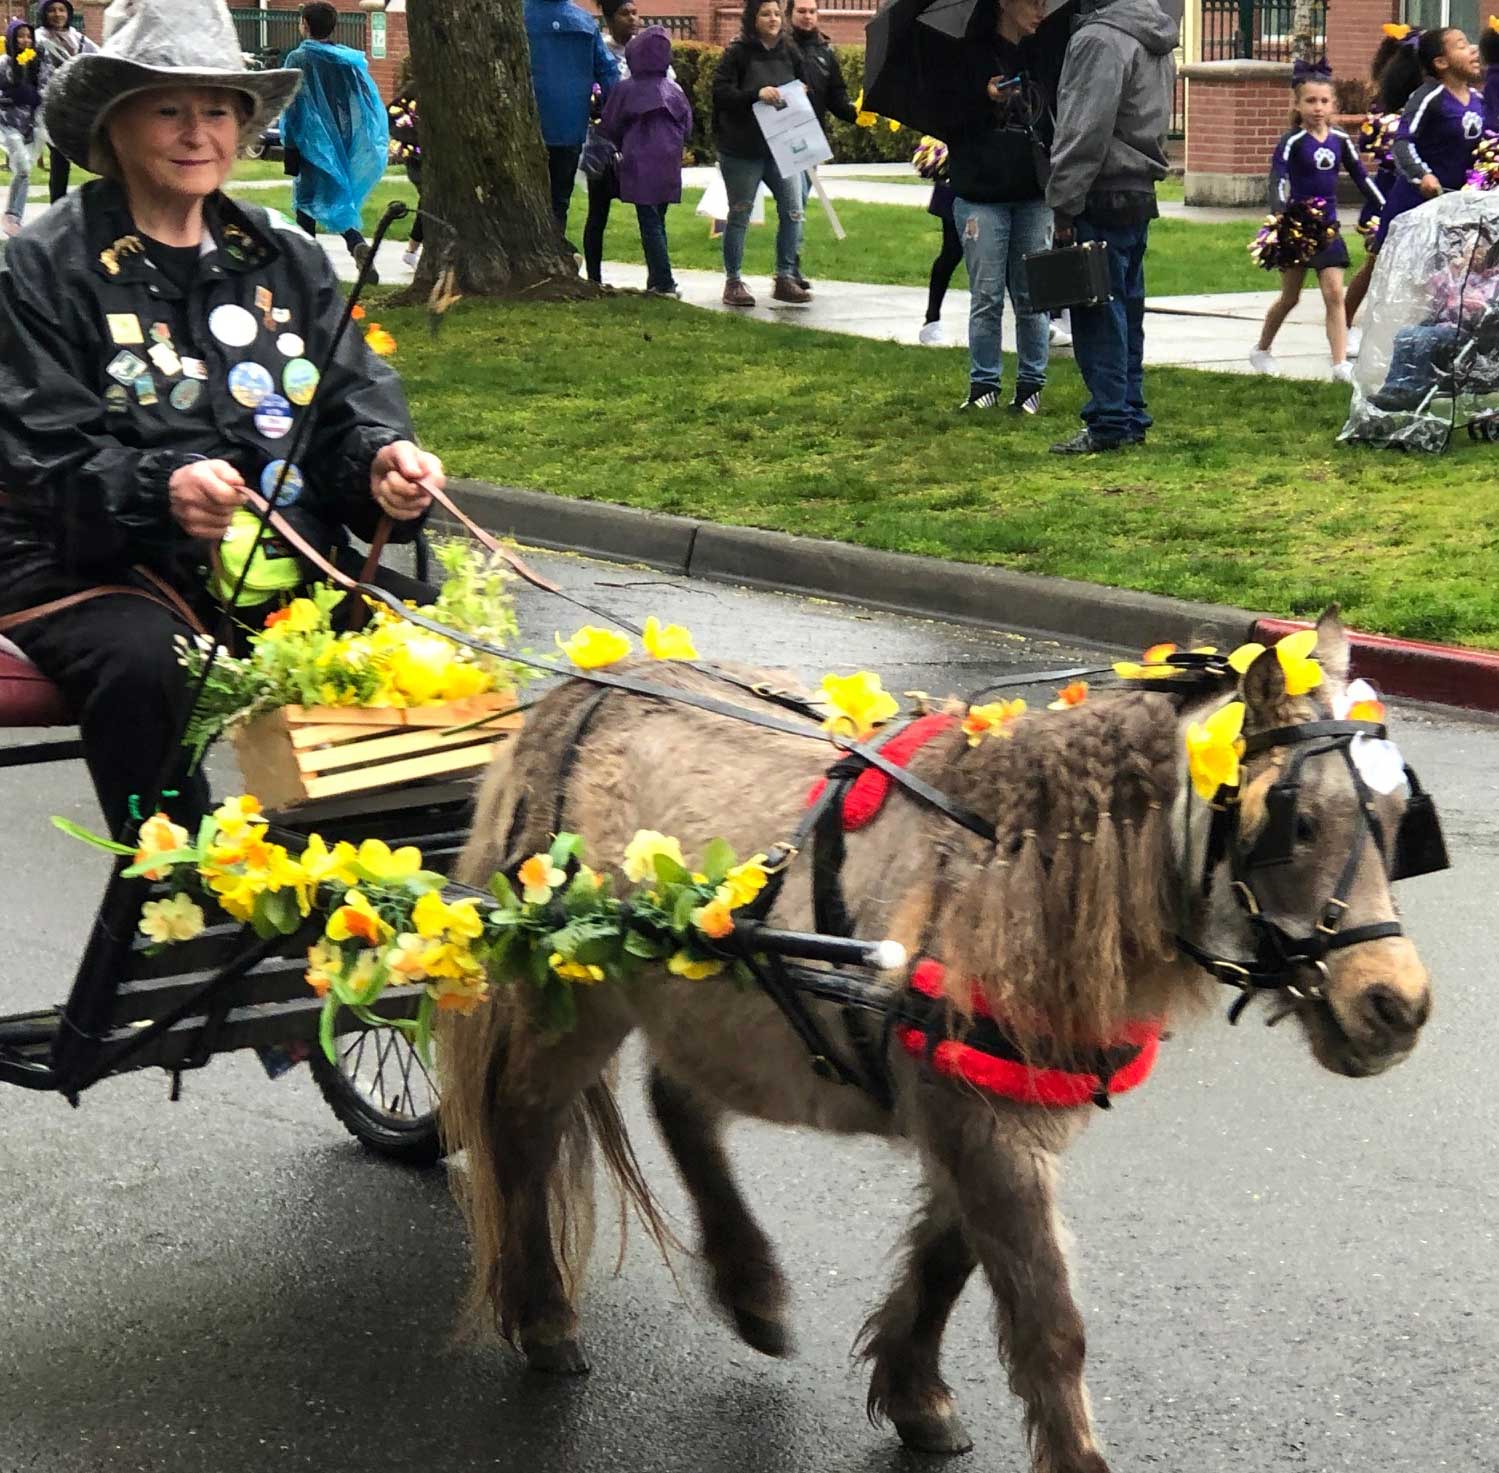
[307,1028,447,1166]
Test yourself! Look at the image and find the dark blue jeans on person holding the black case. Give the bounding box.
[1072,219,1153,445]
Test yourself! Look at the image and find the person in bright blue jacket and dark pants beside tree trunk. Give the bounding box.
[526,0,619,255]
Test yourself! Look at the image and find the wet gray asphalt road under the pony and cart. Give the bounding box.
[0,559,1499,1473]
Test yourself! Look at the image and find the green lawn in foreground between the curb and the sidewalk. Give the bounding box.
[378,295,1499,647]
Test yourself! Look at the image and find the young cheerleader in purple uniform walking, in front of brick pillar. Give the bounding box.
[1249,60,1384,384]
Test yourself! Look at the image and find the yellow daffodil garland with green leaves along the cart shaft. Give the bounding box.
[52,794,769,1059]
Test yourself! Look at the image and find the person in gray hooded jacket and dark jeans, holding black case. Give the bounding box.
[1046,0,1180,456]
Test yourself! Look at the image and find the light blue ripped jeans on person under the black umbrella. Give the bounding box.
[952,199,1051,388]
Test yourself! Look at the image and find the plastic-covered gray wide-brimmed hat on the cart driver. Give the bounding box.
[43,0,301,174]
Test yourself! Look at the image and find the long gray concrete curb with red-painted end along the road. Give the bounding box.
[451,481,1499,712]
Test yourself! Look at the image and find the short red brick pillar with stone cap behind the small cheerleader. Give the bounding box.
[1181,58,1289,205]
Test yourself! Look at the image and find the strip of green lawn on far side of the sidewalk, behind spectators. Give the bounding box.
[246,180,1274,297]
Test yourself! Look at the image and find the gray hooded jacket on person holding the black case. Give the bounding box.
[1046,0,1180,225]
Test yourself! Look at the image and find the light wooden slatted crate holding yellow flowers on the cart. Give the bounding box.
[231,691,522,809]
